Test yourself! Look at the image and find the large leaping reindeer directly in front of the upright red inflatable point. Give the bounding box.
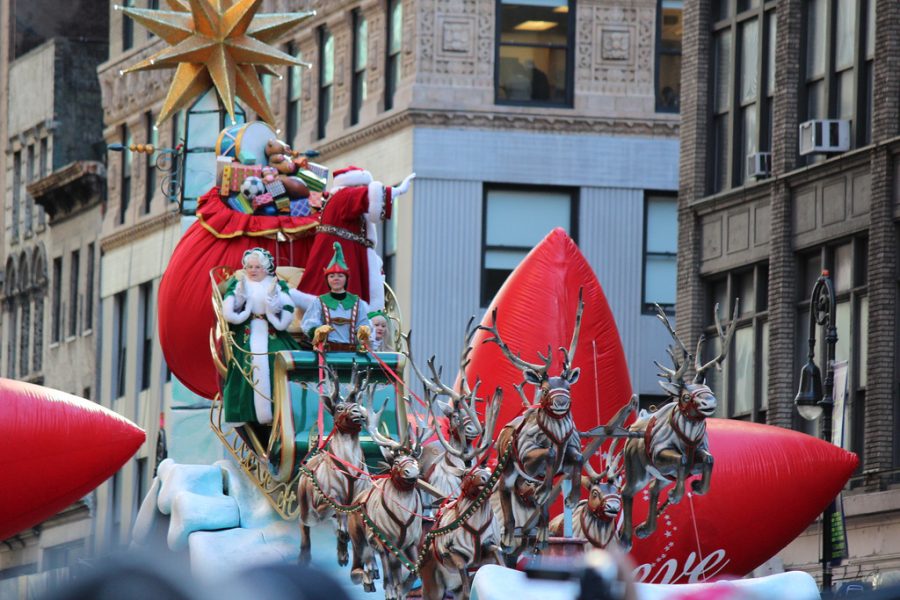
[479,291,584,554]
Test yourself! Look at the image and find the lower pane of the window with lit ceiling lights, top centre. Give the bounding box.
[499,46,566,102]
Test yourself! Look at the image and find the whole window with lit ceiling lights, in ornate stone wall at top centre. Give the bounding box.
[495,0,572,106]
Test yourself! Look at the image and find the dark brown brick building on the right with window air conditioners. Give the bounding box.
[677,0,900,583]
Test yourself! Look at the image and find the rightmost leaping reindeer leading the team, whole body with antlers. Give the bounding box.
[622,300,738,551]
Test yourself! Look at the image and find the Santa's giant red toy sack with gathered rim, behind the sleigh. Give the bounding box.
[159,188,317,399]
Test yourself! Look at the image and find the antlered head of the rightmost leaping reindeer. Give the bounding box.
[654,300,738,420]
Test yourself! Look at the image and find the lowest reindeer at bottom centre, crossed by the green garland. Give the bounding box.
[419,467,503,600]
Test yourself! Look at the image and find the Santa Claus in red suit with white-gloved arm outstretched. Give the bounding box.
[297,166,416,310]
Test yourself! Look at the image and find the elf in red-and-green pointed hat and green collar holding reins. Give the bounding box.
[300,242,371,352]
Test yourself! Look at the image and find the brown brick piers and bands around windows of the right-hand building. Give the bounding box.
[677,0,900,582]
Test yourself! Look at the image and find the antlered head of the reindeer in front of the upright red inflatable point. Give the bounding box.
[478,289,584,418]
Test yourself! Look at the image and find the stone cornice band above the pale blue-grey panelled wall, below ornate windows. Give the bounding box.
[317,108,679,156]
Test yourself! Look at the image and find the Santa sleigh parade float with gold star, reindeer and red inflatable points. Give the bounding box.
[0,0,857,600]
